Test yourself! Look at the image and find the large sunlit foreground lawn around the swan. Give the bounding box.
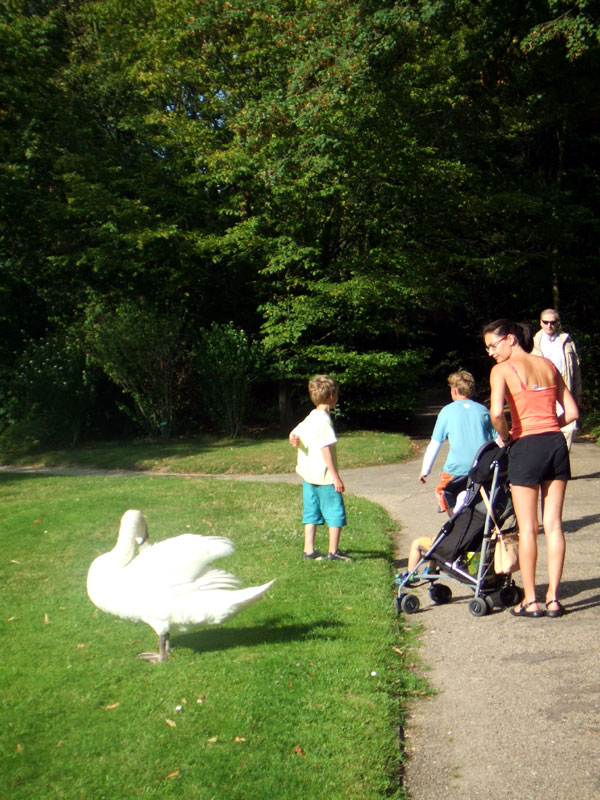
[0,474,422,800]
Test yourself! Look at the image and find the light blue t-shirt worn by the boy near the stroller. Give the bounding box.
[431,400,496,475]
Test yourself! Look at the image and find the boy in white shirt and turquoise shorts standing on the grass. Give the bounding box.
[289,375,354,561]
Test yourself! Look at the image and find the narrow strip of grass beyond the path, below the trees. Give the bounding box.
[0,431,412,475]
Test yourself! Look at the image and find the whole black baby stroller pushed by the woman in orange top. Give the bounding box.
[396,441,523,617]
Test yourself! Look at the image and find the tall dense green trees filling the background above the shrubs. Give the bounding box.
[0,0,600,444]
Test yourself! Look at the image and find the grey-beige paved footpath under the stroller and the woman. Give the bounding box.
[240,442,600,800]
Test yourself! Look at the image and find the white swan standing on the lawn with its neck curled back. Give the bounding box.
[87,510,275,661]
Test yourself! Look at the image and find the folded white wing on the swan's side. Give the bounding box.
[127,533,234,588]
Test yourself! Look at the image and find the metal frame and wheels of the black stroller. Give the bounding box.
[396,441,523,617]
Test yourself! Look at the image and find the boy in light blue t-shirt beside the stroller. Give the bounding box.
[419,370,497,515]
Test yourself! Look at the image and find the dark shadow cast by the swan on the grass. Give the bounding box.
[172,619,341,653]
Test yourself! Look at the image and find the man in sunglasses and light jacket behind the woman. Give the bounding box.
[532,308,581,450]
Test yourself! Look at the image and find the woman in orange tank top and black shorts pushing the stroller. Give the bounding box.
[483,319,579,617]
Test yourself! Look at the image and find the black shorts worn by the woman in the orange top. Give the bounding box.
[508,431,571,486]
